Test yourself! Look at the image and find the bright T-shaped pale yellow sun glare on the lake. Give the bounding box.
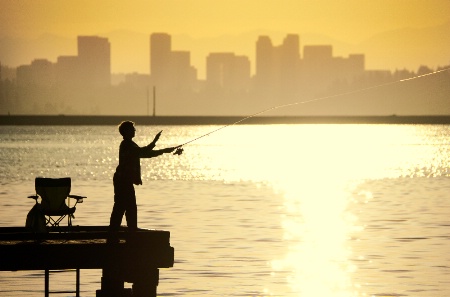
[150,125,450,297]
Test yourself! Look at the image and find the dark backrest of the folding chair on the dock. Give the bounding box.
[35,177,72,210]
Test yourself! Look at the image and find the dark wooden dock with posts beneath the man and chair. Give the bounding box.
[0,226,174,297]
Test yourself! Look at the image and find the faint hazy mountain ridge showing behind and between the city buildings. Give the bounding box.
[0,21,450,79]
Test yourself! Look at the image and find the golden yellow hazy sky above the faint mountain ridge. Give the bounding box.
[0,0,450,74]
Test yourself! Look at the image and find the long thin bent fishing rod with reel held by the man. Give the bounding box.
[173,67,450,155]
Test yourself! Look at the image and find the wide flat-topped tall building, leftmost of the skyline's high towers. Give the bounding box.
[78,36,111,87]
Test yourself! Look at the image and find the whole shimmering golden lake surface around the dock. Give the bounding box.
[0,125,450,297]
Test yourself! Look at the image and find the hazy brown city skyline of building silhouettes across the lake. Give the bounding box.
[1,33,372,89]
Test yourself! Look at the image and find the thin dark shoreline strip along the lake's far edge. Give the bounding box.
[0,115,450,126]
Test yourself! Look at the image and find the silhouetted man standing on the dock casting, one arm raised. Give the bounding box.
[109,121,176,235]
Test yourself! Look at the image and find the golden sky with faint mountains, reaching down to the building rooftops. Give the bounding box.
[0,0,450,78]
